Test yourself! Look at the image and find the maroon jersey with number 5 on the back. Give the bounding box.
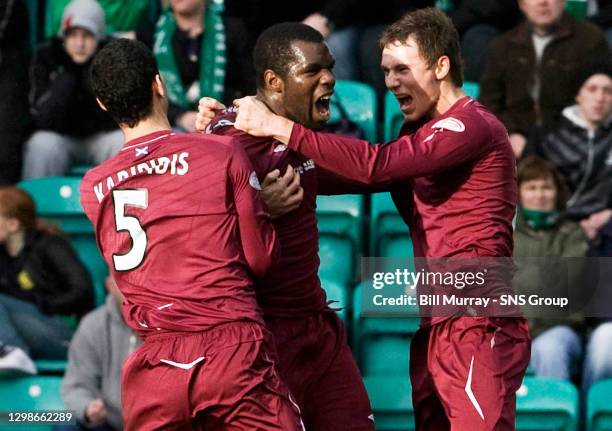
[81,131,276,334]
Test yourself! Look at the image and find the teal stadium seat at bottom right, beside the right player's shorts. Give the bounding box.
[516,376,580,431]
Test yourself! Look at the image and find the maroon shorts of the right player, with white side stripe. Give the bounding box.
[410,317,531,431]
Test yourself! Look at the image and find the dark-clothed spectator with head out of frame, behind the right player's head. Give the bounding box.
[449,0,521,82]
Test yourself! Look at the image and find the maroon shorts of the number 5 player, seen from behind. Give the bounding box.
[122,323,303,431]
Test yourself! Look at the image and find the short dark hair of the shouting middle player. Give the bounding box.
[253,22,325,88]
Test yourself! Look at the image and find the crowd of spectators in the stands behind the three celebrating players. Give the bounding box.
[0,0,612,429]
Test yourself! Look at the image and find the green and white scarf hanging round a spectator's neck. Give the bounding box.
[153,0,226,109]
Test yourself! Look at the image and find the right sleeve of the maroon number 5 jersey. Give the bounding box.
[229,145,279,276]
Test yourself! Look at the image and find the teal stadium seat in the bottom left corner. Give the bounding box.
[0,376,65,431]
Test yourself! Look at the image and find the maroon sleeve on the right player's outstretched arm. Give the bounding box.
[289,118,491,184]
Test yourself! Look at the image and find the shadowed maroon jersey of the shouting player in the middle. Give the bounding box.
[207,108,380,317]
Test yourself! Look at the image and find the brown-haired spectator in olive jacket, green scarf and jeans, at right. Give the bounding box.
[514,156,587,380]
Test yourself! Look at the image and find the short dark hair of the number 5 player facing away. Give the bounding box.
[91,39,159,127]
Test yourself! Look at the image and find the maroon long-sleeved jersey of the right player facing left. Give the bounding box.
[289,97,517,324]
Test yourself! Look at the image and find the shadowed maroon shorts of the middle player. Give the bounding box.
[266,311,374,431]
